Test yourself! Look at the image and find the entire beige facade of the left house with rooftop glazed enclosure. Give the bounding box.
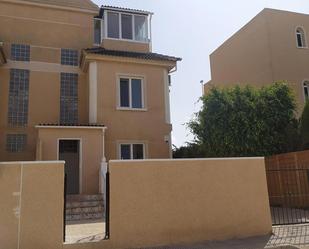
[0,0,180,194]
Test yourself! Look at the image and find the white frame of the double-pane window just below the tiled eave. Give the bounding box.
[117,74,147,111]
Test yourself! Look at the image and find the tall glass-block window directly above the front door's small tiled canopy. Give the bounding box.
[60,73,78,124]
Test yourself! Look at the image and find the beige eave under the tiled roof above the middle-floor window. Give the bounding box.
[80,50,177,72]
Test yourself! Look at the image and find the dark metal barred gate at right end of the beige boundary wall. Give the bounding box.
[266,165,309,225]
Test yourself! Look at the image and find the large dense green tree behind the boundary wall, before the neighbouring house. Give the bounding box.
[188,82,298,157]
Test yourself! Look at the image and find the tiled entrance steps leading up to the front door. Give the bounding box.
[65,195,104,221]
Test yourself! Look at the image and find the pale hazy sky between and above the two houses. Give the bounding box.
[93,0,309,147]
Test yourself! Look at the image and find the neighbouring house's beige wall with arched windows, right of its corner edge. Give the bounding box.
[267,10,309,115]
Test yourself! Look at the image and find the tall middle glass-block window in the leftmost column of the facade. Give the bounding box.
[8,69,30,126]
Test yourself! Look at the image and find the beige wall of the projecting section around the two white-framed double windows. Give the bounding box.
[97,61,172,160]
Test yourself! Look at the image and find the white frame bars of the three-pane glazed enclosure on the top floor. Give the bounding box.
[102,10,150,44]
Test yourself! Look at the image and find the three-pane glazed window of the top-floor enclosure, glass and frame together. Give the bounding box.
[107,11,148,42]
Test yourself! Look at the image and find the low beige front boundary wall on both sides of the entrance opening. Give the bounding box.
[0,158,272,249]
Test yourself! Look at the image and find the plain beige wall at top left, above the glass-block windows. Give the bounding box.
[0,1,95,49]
